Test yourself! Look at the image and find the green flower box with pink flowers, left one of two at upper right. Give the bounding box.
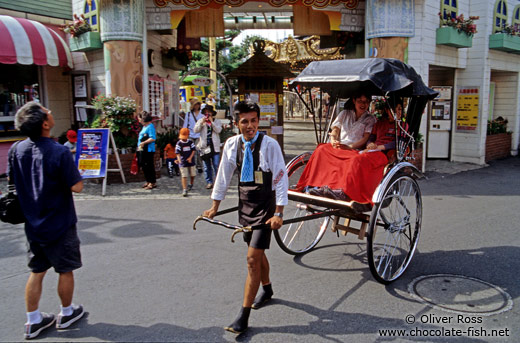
[436,13,479,48]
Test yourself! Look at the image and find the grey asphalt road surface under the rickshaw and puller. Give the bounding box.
[0,154,520,342]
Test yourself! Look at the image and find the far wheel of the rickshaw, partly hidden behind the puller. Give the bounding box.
[273,152,330,255]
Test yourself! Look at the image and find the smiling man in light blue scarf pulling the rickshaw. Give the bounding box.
[203,102,288,334]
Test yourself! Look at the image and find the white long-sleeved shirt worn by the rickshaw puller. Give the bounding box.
[211,135,289,206]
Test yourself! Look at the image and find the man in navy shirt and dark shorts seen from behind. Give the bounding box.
[7,101,84,339]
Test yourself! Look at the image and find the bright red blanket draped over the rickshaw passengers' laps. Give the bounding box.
[296,144,388,204]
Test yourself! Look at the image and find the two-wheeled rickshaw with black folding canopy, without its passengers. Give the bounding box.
[194,58,437,284]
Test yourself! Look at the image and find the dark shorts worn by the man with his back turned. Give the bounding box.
[27,225,82,274]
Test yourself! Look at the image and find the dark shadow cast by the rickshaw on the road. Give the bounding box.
[288,242,520,318]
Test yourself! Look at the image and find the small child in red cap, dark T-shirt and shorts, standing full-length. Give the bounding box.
[175,127,197,197]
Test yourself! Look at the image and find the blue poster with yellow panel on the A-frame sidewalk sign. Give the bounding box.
[76,129,110,179]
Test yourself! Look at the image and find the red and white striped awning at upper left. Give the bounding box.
[0,15,73,68]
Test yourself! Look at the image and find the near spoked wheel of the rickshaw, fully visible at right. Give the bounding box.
[367,174,422,284]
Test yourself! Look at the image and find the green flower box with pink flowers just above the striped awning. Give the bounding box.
[60,14,103,51]
